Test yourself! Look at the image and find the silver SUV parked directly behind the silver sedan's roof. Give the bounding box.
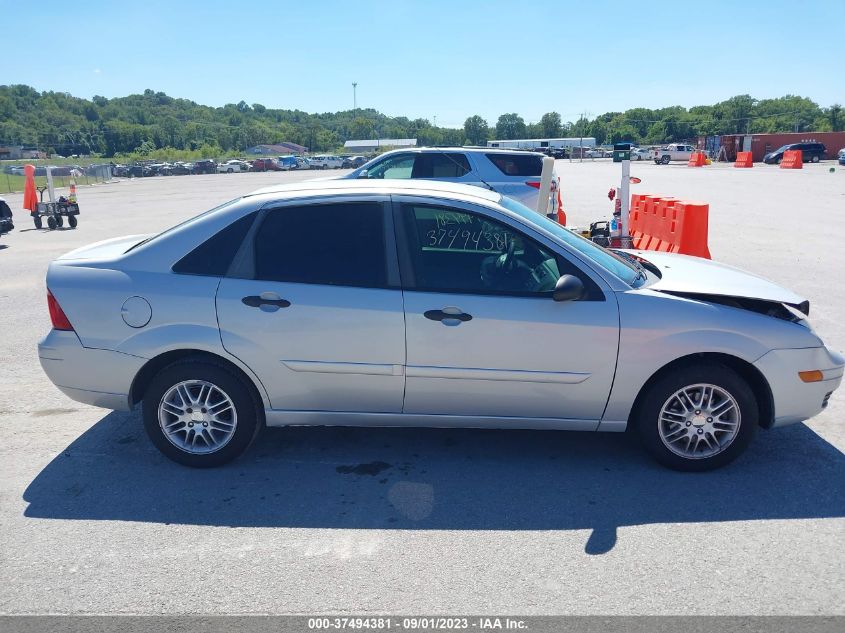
[341,147,562,214]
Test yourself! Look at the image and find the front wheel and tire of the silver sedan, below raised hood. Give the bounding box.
[633,363,760,472]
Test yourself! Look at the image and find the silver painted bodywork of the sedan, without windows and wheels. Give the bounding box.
[39,180,845,431]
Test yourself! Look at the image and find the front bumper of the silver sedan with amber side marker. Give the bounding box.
[754,347,845,428]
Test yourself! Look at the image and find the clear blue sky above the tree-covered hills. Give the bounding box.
[0,0,845,126]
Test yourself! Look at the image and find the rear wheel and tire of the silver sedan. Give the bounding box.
[143,358,264,468]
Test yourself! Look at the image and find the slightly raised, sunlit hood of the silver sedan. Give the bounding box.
[625,250,809,314]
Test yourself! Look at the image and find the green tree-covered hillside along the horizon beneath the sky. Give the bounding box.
[0,85,845,156]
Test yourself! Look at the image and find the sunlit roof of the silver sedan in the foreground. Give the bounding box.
[247,179,501,202]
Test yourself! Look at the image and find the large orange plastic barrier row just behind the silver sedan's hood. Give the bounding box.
[629,194,710,259]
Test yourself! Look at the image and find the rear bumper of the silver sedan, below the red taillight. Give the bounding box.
[38,330,147,411]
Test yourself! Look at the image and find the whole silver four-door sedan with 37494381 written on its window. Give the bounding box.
[39,180,845,470]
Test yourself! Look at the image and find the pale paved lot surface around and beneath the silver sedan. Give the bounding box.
[0,161,845,615]
